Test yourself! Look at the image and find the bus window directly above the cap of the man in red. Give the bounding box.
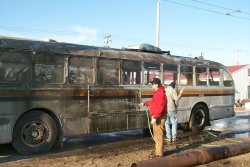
[144,62,160,84]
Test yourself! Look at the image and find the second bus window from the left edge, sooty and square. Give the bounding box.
[33,52,64,83]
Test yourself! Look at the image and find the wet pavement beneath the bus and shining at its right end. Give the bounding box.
[63,111,250,150]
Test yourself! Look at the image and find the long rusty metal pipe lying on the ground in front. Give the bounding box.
[131,141,250,167]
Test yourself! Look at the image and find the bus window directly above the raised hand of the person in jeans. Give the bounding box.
[180,65,193,85]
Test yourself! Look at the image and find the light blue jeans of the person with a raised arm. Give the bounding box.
[165,111,177,139]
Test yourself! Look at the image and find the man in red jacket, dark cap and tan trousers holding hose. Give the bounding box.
[140,78,167,158]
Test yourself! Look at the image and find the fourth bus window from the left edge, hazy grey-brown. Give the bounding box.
[97,58,120,85]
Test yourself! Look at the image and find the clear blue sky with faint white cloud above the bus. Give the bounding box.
[0,0,250,66]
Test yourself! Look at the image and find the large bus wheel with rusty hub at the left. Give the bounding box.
[12,110,57,155]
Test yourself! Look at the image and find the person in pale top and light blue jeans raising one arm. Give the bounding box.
[165,82,185,142]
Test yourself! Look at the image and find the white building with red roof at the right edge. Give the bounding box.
[227,64,250,100]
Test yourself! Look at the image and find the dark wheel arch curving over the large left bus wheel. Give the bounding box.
[16,108,63,147]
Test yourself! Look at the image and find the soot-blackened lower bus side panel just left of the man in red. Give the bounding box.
[89,89,147,133]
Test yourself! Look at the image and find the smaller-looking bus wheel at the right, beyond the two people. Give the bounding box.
[189,104,208,132]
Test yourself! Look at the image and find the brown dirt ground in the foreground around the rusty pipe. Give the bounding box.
[0,132,250,167]
